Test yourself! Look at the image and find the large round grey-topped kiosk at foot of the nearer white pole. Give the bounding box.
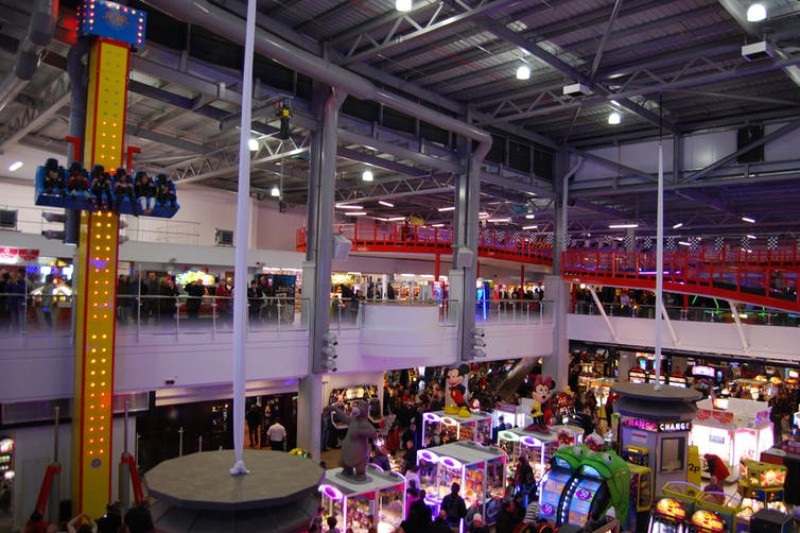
[144,450,324,533]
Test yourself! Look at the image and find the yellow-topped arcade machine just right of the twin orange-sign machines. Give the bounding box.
[736,460,787,525]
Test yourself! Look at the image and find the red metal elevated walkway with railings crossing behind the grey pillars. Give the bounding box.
[297,223,800,312]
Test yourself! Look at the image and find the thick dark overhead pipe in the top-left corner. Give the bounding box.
[0,0,58,111]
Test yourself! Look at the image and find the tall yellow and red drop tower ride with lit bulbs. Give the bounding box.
[36,0,168,516]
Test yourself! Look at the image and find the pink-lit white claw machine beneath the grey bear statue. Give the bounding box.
[319,465,406,533]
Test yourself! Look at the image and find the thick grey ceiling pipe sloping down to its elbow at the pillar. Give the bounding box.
[145,0,492,159]
